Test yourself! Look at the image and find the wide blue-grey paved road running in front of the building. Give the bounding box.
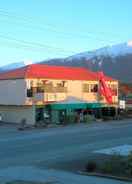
[0,120,132,183]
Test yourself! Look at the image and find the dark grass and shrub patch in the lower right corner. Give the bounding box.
[85,152,132,179]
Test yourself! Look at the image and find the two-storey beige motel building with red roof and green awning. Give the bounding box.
[0,64,118,125]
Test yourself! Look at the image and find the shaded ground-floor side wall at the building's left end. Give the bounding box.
[0,106,35,124]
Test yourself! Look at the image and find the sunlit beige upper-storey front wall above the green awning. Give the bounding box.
[26,79,118,105]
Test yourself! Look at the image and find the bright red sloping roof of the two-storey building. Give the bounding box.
[0,64,113,81]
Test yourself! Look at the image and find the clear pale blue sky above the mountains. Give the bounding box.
[0,0,132,66]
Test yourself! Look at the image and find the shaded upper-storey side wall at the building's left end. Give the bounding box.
[0,79,26,105]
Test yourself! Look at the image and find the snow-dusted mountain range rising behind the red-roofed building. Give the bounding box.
[0,41,132,83]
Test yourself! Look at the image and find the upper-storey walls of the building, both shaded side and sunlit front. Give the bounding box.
[0,79,118,105]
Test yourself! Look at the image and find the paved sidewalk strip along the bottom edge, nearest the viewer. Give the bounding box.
[0,167,129,184]
